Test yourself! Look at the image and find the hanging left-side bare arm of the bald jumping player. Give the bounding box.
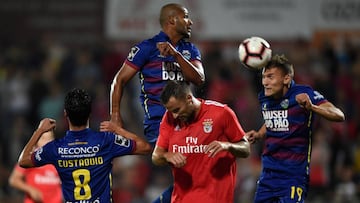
[110,63,137,126]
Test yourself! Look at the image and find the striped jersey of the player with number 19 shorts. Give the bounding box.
[259,82,327,176]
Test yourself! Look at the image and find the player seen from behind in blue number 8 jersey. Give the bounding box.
[19,89,151,203]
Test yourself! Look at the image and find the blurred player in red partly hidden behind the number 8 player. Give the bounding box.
[9,127,63,203]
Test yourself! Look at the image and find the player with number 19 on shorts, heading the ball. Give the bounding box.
[247,55,345,203]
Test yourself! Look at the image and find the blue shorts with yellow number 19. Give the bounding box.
[254,169,309,203]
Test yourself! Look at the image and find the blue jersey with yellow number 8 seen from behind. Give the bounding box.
[32,128,135,203]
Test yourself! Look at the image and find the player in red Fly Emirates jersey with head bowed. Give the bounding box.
[152,81,250,203]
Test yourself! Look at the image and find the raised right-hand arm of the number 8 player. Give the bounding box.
[100,121,152,155]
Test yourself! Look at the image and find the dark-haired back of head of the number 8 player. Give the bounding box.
[64,88,92,126]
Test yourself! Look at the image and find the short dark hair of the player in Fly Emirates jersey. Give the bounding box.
[160,80,191,104]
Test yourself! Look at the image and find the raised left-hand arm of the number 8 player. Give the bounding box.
[18,118,56,168]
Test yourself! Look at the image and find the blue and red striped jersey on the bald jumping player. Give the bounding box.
[125,31,201,124]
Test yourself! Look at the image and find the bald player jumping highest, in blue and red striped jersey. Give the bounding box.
[110,4,205,144]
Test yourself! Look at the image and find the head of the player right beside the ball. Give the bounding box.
[262,55,294,98]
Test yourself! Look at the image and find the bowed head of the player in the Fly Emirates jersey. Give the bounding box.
[160,81,196,121]
